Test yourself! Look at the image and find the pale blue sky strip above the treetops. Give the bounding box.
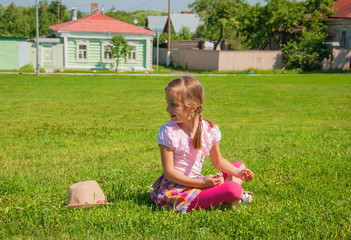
[0,0,264,13]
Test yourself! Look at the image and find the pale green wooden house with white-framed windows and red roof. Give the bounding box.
[46,12,154,71]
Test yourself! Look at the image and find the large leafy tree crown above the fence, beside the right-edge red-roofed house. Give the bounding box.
[239,0,333,53]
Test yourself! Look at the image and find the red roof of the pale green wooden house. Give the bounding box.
[49,12,153,35]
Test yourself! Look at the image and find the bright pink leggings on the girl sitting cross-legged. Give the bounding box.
[187,161,243,212]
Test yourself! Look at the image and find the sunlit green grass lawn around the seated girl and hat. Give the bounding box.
[0,74,351,240]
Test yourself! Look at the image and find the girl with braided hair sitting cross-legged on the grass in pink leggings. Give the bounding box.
[150,77,254,213]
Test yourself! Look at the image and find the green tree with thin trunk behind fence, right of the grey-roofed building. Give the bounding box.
[189,0,244,50]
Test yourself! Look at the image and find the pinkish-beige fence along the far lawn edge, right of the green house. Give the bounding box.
[153,48,351,71]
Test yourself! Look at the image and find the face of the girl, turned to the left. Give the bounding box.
[166,89,194,123]
